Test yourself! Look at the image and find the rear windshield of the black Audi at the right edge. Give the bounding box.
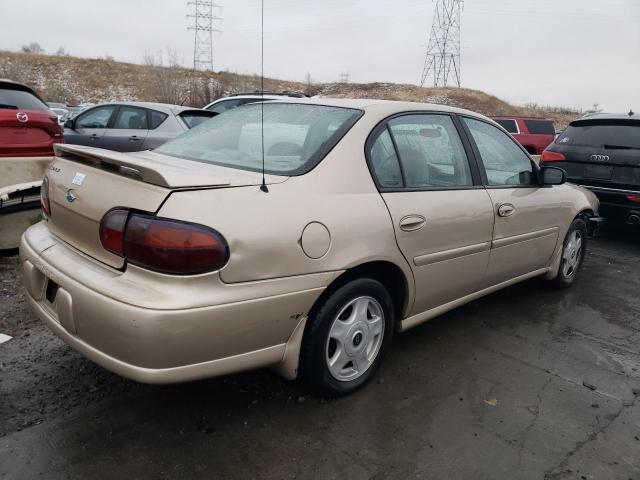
[556,124,640,149]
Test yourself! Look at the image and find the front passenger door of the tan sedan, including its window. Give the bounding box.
[463,117,570,287]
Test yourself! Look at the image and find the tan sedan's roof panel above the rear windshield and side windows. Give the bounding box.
[262,97,491,121]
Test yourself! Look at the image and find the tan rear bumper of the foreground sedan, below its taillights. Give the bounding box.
[20,223,332,383]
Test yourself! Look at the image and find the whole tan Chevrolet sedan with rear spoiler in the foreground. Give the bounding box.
[21,99,598,396]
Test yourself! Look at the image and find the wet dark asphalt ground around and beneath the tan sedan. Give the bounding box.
[0,229,640,480]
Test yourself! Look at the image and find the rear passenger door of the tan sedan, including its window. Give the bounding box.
[367,113,493,315]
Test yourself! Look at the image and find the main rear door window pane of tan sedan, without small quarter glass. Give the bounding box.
[388,114,473,188]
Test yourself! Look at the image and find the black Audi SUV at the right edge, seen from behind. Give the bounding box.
[540,112,640,225]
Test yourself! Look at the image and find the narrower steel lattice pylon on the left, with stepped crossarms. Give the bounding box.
[187,0,222,70]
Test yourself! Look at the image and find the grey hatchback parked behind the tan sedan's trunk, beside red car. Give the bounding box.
[64,102,215,152]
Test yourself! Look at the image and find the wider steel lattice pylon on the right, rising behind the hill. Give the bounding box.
[420,0,463,87]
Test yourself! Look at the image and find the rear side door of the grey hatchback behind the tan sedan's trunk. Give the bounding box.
[102,105,149,152]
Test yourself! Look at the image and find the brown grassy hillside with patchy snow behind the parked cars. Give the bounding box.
[0,51,581,127]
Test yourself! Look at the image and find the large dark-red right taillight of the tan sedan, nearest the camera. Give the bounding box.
[100,208,229,275]
